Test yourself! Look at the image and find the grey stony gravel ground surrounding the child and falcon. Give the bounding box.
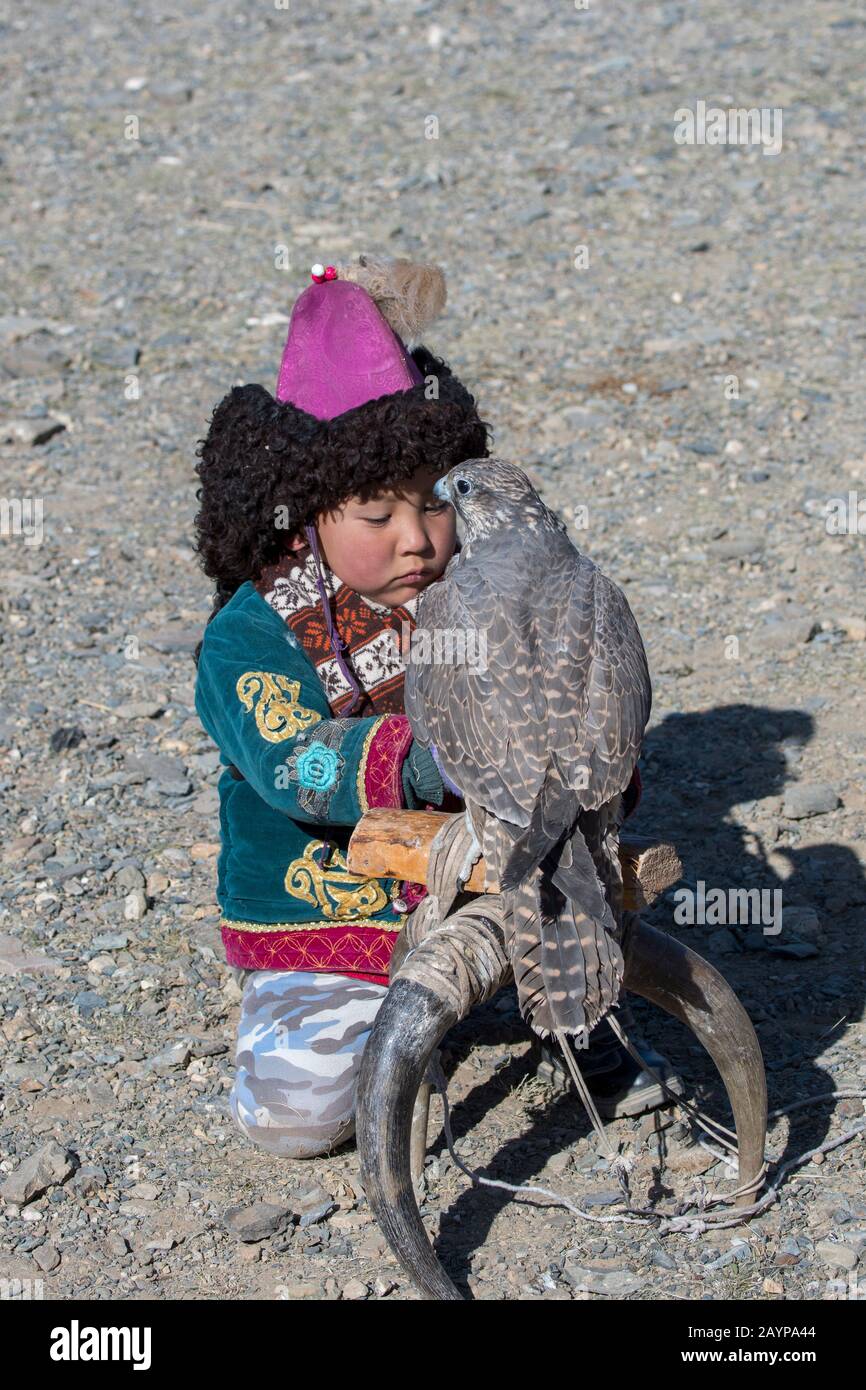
[0,0,866,1300]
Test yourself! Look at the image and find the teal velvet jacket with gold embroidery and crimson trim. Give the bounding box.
[196,582,444,983]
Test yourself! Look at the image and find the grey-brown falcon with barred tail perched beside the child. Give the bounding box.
[405,459,652,1037]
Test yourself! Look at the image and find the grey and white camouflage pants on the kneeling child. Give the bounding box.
[229,970,388,1158]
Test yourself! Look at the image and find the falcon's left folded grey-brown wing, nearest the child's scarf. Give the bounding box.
[405,550,548,827]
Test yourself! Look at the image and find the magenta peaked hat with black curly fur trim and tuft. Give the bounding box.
[196,257,489,612]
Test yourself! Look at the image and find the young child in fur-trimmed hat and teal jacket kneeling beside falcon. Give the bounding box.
[196,257,678,1158]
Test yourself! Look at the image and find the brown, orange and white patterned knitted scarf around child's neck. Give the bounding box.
[256,552,418,716]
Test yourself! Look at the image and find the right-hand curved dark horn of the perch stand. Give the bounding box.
[623,916,767,1207]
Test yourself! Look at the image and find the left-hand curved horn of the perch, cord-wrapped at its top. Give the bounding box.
[356,897,512,1300]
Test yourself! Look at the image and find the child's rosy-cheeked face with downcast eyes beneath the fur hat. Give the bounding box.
[318,468,457,607]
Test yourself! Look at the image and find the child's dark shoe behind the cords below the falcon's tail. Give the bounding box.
[535,1015,683,1120]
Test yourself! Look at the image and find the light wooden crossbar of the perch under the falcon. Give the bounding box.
[346,809,683,912]
